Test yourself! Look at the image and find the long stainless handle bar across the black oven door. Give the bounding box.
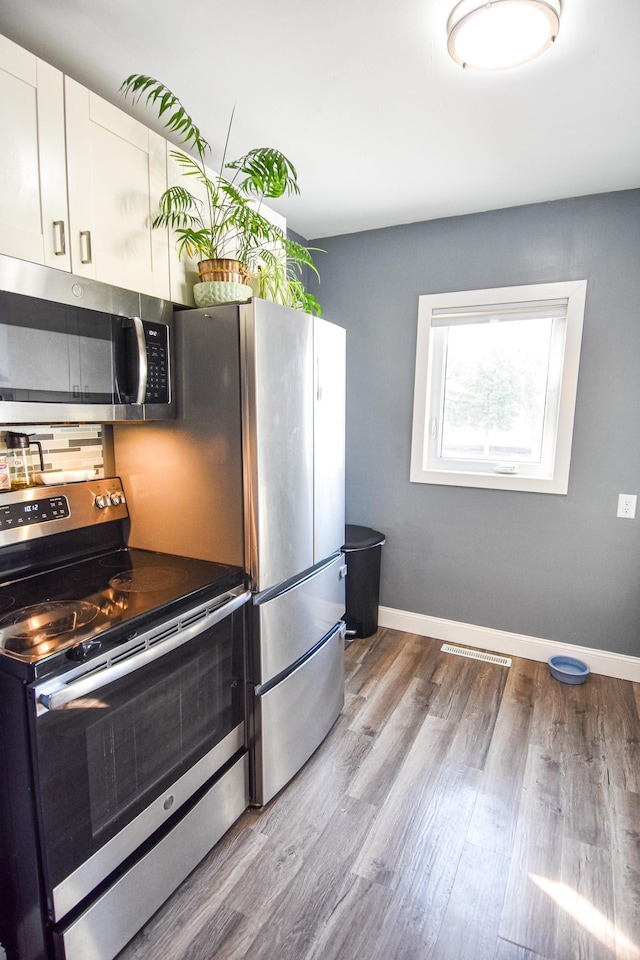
[34,590,251,713]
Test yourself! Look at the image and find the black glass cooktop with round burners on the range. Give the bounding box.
[0,548,243,663]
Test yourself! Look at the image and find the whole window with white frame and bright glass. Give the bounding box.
[411,281,586,493]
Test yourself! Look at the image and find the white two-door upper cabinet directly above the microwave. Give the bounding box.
[0,36,170,298]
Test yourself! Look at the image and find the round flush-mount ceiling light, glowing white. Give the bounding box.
[447,0,560,70]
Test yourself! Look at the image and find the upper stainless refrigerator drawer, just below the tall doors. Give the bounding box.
[249,554,346,684]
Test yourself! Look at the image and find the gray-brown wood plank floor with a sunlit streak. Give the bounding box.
[118,629,640,960]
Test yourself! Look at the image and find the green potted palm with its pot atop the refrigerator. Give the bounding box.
[120,74,321,314]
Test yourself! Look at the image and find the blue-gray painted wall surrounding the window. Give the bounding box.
[313,190,640,655]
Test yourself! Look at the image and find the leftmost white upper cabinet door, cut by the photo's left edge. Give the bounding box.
[0,36,71,270]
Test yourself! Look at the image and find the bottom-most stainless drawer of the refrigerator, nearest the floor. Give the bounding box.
[251,623,344,805]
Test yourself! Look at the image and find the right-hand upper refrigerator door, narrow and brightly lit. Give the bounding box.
[313,317,346,563]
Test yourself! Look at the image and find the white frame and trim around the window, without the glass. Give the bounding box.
[410,280,587,494]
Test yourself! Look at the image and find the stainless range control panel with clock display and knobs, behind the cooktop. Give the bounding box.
[0,477,129,547]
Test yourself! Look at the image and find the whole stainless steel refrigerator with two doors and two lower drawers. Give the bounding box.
[114,299,346,804]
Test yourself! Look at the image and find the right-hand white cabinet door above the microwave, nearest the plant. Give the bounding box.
[65,77,169,297]
